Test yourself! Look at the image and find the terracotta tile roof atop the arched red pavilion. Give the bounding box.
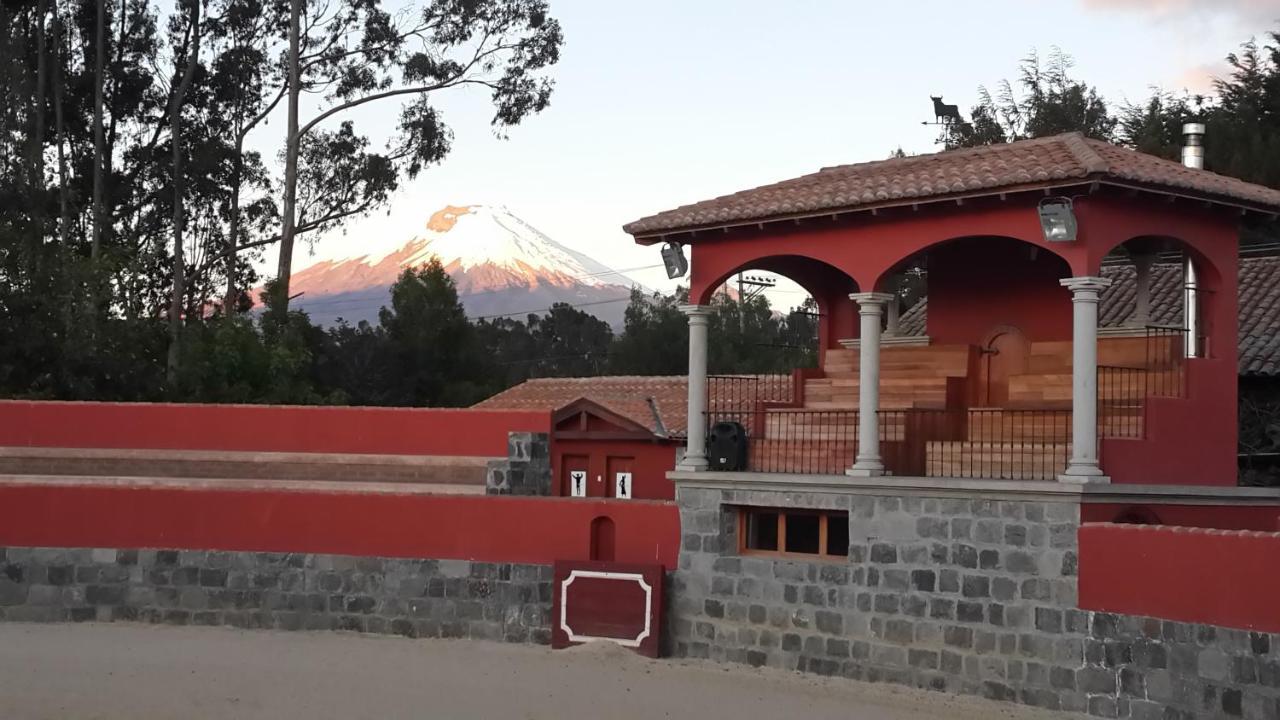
[622,133,1280,237]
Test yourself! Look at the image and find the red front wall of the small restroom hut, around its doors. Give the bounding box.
[552,439,676,500]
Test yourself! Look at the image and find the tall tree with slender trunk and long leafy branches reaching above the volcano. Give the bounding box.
[275,0,562,310]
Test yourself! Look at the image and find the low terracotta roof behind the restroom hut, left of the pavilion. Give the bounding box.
[475,375,689,436]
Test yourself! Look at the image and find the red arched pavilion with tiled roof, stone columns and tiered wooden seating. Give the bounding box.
[626,128,1280,517]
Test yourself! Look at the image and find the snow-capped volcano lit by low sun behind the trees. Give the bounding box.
[289,205,632,324]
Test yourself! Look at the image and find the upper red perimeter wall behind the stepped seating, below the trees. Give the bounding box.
[0,400,550,457]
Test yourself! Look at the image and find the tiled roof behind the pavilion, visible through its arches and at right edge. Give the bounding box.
[899,258,1280,375]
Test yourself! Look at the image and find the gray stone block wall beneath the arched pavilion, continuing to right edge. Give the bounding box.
[668,484,1280,720]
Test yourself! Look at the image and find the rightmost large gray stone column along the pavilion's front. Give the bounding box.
[1057,277,1111,483]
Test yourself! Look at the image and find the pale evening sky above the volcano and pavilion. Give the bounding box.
[262,0,1280,305]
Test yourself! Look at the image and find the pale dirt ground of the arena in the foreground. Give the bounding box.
[0,623,1080,720]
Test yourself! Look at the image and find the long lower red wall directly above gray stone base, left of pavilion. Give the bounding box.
[0,486,680,569]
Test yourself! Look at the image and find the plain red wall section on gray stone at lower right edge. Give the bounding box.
[1079,524,1280,633]
